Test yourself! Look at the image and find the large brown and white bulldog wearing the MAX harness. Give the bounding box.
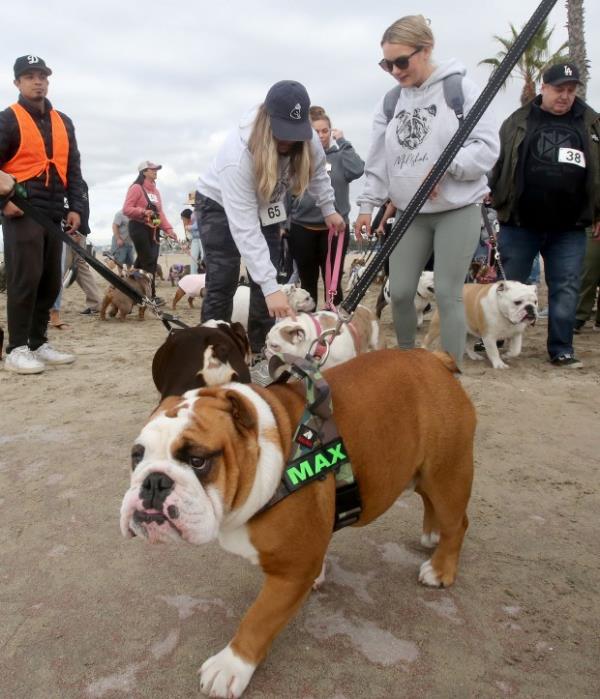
[121,350,475,697]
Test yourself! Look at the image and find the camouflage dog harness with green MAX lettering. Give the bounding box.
[259,354,362,531]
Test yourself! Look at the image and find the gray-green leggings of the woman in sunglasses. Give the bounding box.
[390,204,481,363]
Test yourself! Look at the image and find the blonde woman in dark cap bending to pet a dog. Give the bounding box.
[196,80,345,353]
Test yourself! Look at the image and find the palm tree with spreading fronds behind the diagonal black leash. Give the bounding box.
[479,20,568,105]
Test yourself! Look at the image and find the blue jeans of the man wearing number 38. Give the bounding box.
[499,225,585,359]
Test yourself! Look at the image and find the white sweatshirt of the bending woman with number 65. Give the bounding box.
[196,110,335,296]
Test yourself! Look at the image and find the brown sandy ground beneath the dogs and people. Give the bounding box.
[0,255,600,699]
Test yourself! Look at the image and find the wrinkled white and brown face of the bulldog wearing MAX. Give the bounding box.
[120,391,224,544]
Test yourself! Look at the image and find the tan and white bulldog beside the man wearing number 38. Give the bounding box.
[423,281,538,369]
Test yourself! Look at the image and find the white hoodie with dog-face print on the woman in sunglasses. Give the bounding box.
[357,60,500,214]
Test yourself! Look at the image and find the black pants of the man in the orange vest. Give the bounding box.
[2,216,62,353]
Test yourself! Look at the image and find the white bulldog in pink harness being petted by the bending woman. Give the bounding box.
[265,306,379,367]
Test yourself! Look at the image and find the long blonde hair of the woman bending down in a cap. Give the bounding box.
[248,104,314,204]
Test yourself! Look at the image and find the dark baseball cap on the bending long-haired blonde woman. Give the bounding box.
[265,80,313,141]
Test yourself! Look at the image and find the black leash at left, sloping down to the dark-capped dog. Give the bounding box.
[10,191,189,331]
